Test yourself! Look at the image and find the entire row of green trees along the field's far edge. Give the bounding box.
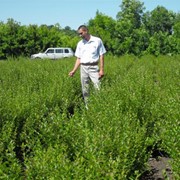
[0,0,180,59]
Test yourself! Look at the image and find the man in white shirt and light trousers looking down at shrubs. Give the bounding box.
[69,25,106,107]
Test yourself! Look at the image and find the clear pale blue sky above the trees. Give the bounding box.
[0,0,180,30]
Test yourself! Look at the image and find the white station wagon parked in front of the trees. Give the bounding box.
[31,47,74,59]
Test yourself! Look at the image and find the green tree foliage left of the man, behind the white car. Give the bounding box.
[0,19,78,59]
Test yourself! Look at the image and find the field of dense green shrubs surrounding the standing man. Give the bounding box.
[0,56,180,180]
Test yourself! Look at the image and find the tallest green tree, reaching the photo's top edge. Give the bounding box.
[114,0,148,55]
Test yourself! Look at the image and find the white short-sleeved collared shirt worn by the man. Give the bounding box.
[75,35,106,63]
